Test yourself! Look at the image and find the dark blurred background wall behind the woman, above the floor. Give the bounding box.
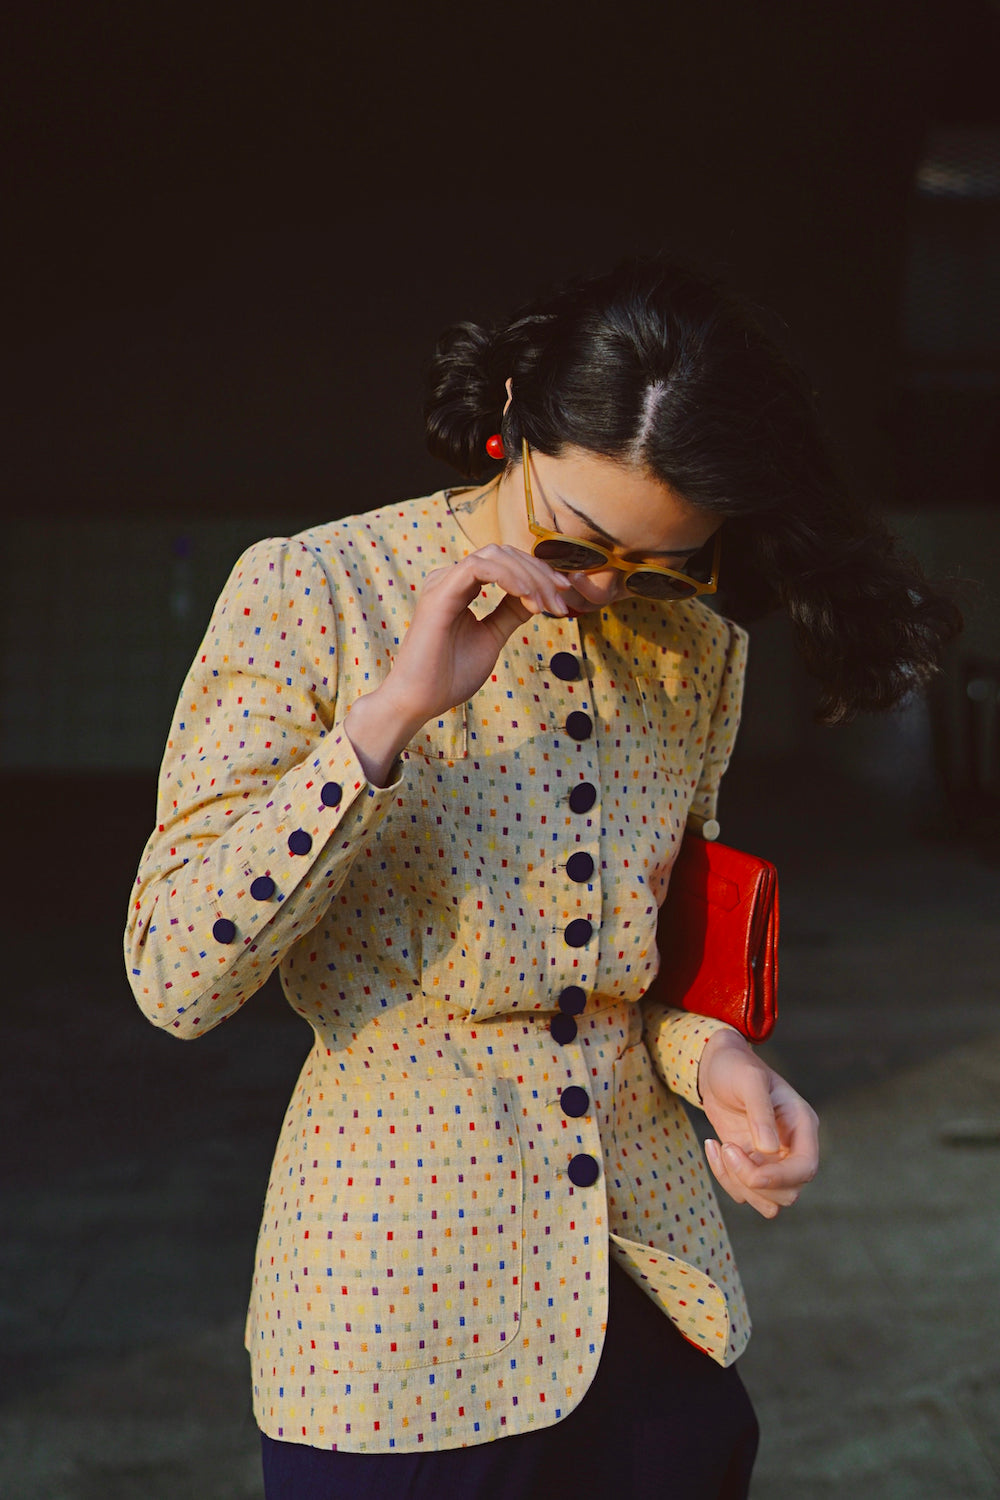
[0,0,1000,917]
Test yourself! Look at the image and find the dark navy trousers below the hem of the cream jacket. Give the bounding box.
[262,1263,757,1500]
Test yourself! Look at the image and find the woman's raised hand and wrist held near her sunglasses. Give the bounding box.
[345,543,573,786]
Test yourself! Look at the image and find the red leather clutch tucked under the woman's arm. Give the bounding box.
[654,834,778,1041]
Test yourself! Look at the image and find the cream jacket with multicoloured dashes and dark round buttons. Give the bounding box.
[126,492,750,1452]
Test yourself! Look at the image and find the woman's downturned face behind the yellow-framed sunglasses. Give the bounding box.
[498,447,720,614]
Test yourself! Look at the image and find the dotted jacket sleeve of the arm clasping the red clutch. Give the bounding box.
[642,623,747,1104]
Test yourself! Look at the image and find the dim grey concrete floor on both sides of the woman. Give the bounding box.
[0,768,1000,1500]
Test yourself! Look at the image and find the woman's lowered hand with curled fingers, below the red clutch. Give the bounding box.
[699,1031,819,1218]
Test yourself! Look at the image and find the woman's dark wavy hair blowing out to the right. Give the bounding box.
[424,258,961,723]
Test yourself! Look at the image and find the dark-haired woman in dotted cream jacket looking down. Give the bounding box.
[126,261,955,1500]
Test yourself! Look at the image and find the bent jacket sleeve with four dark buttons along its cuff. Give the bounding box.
[124,539,399,1037]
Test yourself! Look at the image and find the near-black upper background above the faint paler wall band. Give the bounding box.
[3,0,997,516]
